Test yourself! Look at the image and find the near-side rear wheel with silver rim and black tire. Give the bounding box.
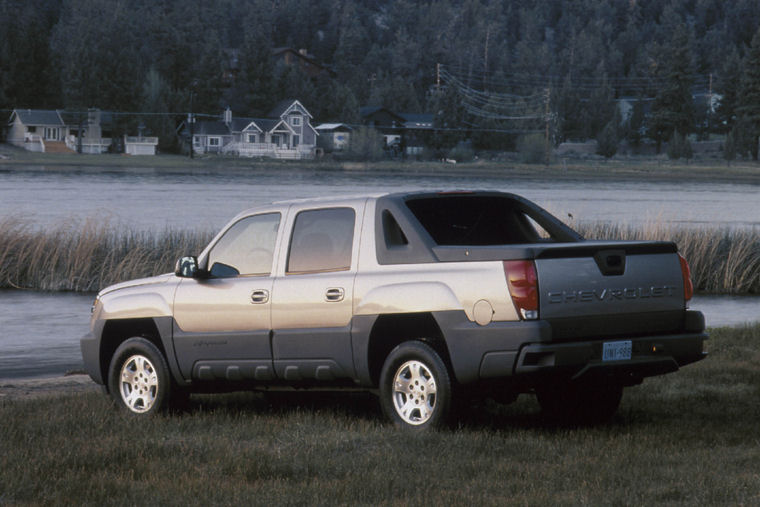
[380,341,452,431]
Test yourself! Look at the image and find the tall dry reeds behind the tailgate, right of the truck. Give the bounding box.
[572,220,760,294]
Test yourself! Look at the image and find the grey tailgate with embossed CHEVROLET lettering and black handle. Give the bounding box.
[535,242,685,338]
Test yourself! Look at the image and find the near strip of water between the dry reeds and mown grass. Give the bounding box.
[0,290,760,379]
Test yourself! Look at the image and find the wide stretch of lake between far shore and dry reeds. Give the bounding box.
[0,166,760,230]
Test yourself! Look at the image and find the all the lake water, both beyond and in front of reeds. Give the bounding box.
[0,165,760,378]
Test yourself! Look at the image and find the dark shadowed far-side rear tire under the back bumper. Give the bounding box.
[536,383,623,425]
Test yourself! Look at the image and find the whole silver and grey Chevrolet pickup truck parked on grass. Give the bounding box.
[81,191,707,430]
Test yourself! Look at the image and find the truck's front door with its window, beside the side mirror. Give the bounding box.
[174,213,281,381]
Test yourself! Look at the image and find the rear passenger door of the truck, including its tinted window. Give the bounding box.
[272,205,363,381]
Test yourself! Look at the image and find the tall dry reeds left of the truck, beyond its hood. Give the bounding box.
[0,217,211,292]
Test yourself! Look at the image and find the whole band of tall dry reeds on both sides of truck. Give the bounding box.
[0,217,760,294]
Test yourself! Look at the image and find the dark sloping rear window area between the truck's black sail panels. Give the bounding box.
[406,195,554,246]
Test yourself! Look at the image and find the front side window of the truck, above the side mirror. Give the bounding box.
[208,213,280,278]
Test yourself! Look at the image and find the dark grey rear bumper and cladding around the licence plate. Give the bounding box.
[435,311,708,386]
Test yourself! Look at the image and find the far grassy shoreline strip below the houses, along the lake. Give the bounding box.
[0,145,760,185]
